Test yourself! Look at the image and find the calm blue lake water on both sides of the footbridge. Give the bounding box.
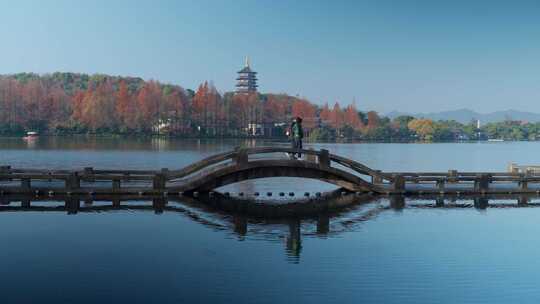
[0,138,540,303]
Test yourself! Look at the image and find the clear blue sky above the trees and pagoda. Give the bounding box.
[0,0,540,112]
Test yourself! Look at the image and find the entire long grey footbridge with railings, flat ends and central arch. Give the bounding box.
[0,147,540,195]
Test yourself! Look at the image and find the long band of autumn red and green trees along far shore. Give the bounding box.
[0,73,540,141]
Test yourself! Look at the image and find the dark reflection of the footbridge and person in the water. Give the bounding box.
[0,194,540,262]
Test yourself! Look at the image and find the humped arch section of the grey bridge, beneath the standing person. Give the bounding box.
[165,147,390,193]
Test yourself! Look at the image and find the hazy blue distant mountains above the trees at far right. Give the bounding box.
[386,109,540,124]
